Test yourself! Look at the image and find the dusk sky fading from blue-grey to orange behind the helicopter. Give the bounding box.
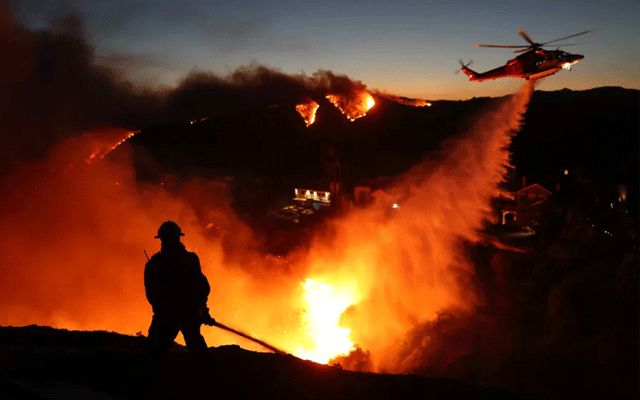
[10,0,640,99]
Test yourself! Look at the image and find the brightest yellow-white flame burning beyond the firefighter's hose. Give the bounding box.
[296,279,356,364]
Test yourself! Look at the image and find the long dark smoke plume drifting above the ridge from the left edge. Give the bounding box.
[0,8,376,178]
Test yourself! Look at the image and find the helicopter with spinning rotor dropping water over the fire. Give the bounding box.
[456,29,595,82]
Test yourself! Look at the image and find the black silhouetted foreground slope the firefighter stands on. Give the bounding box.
[0,326,515,400]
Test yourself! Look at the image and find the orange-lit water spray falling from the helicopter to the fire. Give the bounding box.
[298,82,534,372]
